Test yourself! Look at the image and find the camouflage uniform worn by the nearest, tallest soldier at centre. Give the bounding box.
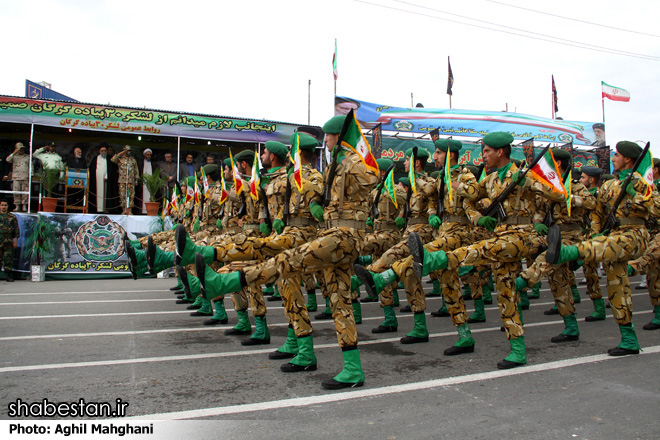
[244,146,378,350]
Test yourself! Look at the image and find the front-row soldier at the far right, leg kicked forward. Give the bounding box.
[546,141,660,356]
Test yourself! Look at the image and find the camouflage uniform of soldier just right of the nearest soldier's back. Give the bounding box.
[367,172,438,313]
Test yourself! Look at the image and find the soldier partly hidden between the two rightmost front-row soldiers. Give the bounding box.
[515,148,596,343]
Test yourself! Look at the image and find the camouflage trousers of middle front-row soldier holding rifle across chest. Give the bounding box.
[443,226,540,339]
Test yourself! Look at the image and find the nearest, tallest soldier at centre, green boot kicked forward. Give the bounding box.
[197,116,378,389]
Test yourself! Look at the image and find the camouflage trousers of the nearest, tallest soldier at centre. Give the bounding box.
[245,227,364,348]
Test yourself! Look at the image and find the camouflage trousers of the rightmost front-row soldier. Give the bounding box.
[577,226,649,325]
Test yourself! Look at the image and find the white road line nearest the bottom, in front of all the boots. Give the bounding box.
[122,345,660,420]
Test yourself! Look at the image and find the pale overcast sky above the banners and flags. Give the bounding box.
[0,0,660,156]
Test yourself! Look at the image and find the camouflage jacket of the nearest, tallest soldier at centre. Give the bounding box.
[323,146,378,221]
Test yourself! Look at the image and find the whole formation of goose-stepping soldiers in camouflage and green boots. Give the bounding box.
[121,112,660,389]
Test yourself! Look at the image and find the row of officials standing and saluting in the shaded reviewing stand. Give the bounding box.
[0,142,222,214]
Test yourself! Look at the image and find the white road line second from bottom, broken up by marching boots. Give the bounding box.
[0,312,651,374]
